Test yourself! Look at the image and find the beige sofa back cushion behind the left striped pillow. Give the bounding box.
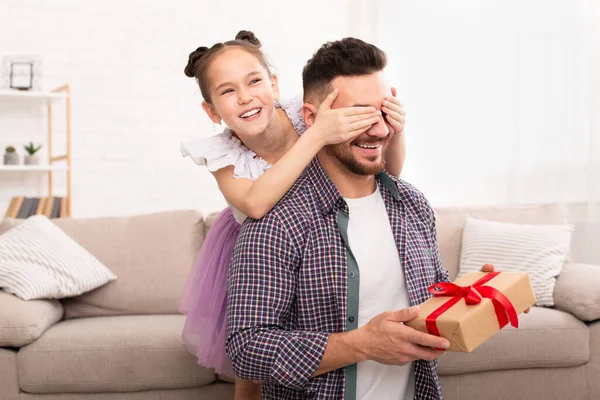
[54,211,204,319]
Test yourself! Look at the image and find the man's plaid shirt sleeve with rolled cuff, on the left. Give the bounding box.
[226,212,329,389]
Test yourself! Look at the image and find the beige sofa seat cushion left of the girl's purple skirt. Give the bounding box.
[17,315,216,393]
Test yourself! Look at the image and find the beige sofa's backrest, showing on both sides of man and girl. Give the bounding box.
[0,204,567,318]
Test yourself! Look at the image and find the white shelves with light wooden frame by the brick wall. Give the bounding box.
[0,84,71,217]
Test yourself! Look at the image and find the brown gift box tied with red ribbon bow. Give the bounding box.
[405,272,536,352]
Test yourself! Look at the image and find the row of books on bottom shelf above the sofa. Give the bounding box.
[4,196,67,219]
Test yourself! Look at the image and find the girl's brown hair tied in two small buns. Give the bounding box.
[183,31,271,103]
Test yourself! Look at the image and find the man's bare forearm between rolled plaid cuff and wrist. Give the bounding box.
[312,330,365,377]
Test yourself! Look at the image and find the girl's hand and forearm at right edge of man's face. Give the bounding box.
[381,88,406,177]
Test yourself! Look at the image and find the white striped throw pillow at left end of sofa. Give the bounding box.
[0,215,117,300]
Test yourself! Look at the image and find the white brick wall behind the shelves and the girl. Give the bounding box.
[0,0,354,217]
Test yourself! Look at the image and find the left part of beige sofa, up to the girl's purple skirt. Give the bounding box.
[0,211,233,400]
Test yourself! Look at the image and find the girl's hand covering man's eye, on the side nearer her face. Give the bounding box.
[311,89,381,146]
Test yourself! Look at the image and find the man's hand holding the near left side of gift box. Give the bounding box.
[357,307,450,365]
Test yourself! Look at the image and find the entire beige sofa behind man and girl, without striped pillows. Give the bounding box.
[0,205,600,400]
